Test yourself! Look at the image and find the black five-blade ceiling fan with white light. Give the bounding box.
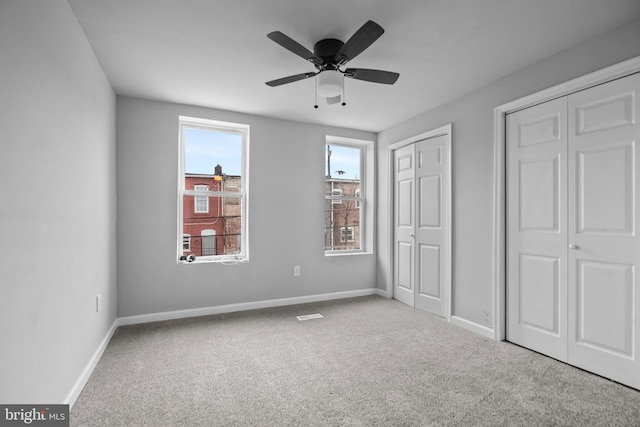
[266,21,400,108]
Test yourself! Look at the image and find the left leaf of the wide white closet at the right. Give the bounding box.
[507,99,567,360]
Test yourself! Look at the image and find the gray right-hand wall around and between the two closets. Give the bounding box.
[377,16,640,328]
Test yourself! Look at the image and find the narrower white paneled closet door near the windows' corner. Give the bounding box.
[394,134,450,317]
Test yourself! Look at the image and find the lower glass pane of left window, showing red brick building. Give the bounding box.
[182,195,242,257]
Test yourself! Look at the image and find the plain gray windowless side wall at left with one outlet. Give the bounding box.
[0,0,116,403]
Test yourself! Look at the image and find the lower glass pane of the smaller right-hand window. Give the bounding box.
[324,200,360,251]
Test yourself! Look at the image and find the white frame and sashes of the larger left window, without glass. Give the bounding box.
[176,115,250,265]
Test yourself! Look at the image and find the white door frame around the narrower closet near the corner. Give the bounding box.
[387,123,453,322]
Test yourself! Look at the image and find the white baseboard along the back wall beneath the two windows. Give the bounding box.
[119,288,384,326]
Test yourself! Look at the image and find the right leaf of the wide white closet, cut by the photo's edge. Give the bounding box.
[568,74,640,388]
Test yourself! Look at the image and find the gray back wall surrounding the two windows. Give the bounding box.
[117,97,376,317]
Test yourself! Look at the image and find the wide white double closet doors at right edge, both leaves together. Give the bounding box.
[507,75,640,388]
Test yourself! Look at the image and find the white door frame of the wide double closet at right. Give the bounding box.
[492,56,640,341]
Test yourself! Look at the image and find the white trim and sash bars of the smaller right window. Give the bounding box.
[323,135,375,257]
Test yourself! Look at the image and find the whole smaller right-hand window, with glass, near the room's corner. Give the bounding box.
[324,137,373,255]
